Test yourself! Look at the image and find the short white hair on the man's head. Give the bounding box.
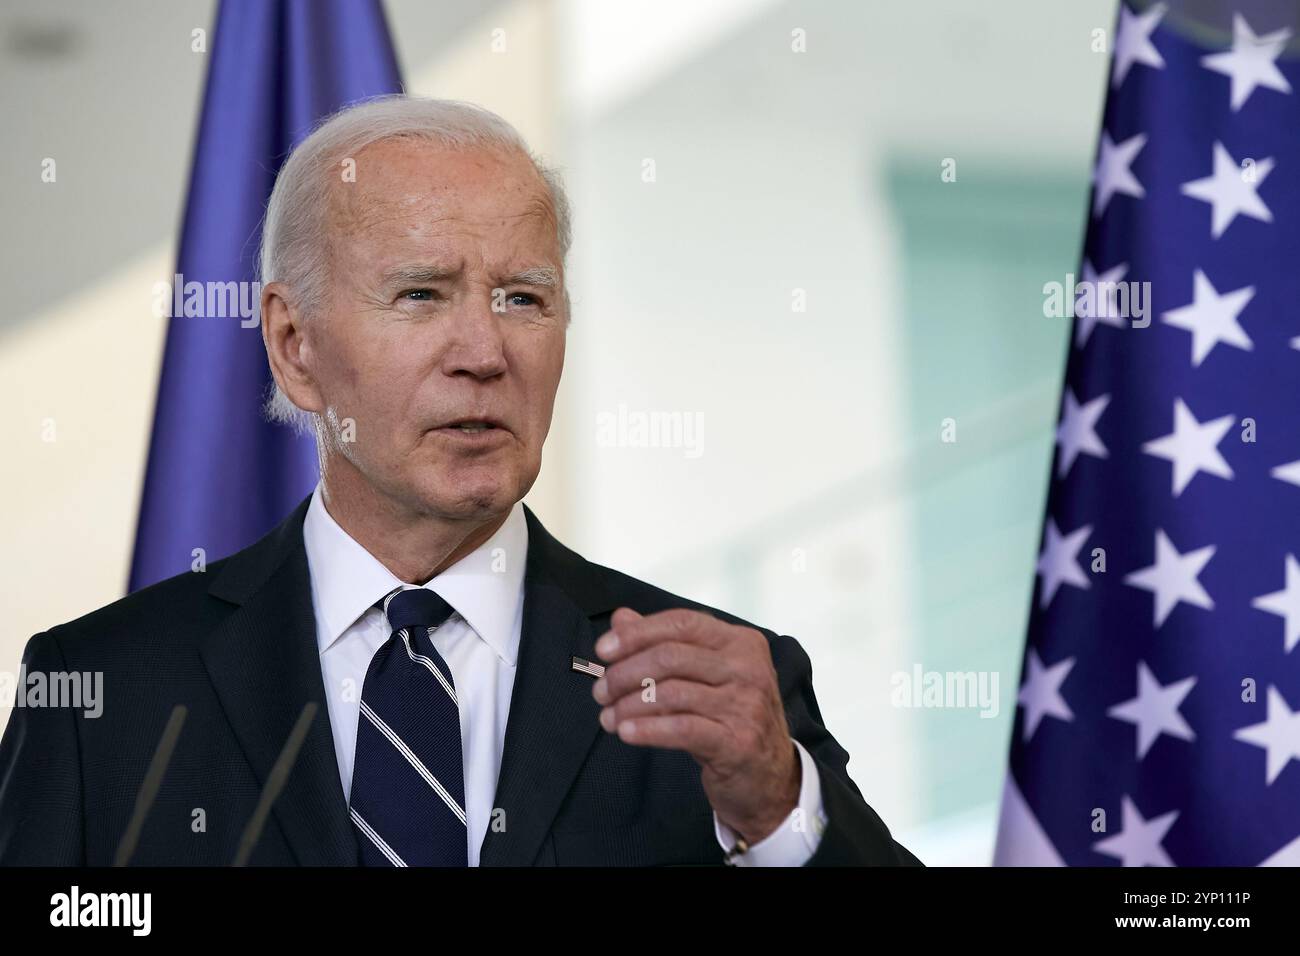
[259,94,572,434]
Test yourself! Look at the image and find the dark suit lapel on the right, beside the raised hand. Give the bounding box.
[480,506,608,866]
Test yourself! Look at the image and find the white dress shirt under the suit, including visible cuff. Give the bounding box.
[303,484,826,866]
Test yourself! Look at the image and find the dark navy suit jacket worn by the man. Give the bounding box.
[0,498,919,866]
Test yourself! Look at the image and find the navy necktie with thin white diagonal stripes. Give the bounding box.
[350,588,469,866]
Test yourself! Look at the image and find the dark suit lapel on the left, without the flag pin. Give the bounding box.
[199,498,358,865]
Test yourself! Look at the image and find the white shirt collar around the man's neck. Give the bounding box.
[303,483,528,666]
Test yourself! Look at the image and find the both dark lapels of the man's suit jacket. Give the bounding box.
[199,497,614,866]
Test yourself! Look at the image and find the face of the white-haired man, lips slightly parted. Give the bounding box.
[302,140,567,519]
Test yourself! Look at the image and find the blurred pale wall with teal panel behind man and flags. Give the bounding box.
[0,0,1115,864]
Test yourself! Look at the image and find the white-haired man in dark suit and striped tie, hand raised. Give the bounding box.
[0,98,918,866]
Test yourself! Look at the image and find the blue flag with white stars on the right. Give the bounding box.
[995,0,1300,866]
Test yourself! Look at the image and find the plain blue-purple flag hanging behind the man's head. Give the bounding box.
[130,0,400,591]
